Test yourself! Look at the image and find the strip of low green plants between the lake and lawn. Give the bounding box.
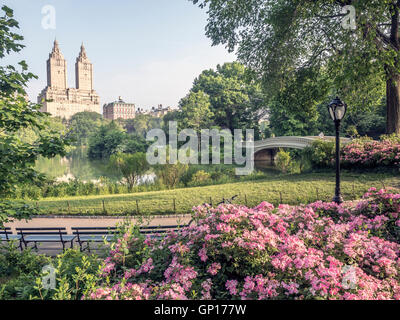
[12,162,260,200]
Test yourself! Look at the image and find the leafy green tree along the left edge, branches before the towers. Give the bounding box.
[0,6,66,226]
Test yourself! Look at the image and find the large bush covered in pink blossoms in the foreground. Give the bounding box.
[84,189,400,300]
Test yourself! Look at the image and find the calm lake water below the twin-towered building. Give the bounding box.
[36,148,155,183]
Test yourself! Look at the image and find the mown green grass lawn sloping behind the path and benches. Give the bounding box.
[30,173,400,216]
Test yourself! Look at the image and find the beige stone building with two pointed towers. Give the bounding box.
[38,40,100,119]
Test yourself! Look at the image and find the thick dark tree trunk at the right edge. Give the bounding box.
[386,75,400,134]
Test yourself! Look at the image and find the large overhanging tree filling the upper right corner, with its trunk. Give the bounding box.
[191,0,400,133]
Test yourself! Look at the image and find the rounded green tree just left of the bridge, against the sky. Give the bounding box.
[178,62,267,137]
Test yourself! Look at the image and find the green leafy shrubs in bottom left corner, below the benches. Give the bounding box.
[0,244,102,300]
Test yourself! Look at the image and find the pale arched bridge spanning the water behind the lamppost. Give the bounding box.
[248,136,350,166]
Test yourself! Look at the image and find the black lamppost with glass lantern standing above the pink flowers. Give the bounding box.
[328,97,347,204]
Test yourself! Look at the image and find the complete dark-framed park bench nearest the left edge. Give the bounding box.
[16,228,76,250]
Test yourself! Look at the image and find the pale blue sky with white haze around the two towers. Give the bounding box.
[0,0,236,109]
